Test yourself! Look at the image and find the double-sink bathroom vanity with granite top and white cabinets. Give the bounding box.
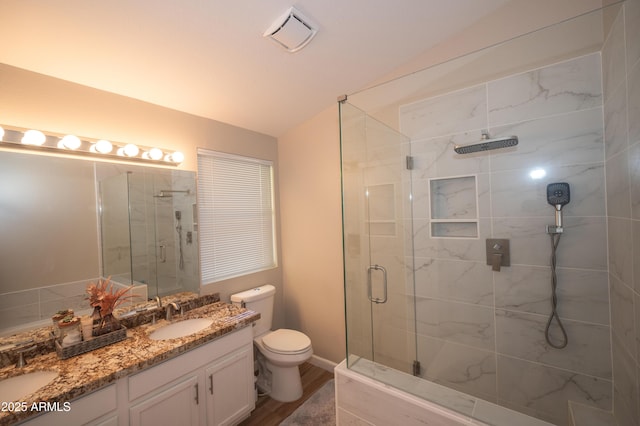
[0,302,259,426]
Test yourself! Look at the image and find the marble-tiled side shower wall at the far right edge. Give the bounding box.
[602,0,640,426]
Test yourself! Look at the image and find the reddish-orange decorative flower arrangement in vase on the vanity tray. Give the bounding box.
[87,277,135,336]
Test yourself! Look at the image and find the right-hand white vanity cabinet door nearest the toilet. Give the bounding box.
[205,346,255,426]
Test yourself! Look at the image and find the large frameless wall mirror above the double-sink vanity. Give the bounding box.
[0,151,199,335]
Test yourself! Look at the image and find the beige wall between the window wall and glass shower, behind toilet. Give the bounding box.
[278,103,346,363]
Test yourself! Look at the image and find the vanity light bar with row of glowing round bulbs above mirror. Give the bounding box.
[0,125,184,166]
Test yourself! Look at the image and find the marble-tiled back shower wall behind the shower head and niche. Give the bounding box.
[400,53,608,424]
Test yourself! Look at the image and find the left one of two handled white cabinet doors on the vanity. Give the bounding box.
[129,375,200,426]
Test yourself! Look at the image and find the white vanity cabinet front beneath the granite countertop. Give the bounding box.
[18,326,255,426]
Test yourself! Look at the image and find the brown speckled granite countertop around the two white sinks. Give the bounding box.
[0,302,260,426]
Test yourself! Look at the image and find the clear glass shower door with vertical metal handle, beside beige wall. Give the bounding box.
[340,102,416,373]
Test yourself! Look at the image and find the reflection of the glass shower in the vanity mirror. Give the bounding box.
[97,163,199,298]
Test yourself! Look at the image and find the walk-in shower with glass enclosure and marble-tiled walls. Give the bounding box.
[338,4,640,425]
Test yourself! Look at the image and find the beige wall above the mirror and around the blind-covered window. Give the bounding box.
[0,64,284,327]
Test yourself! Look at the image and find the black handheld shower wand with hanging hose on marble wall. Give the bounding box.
[544,182,571,349]
